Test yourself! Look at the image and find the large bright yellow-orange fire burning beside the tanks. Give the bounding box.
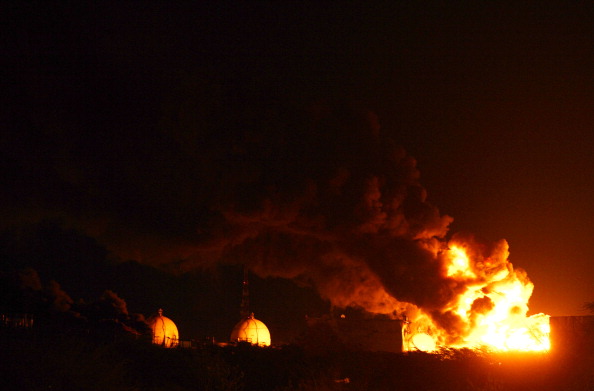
[405,240,550,351]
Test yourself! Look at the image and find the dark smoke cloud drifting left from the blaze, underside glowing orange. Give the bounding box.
[4,95,456,322]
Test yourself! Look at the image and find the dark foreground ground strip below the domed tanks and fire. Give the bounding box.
[0,330,594,391]
